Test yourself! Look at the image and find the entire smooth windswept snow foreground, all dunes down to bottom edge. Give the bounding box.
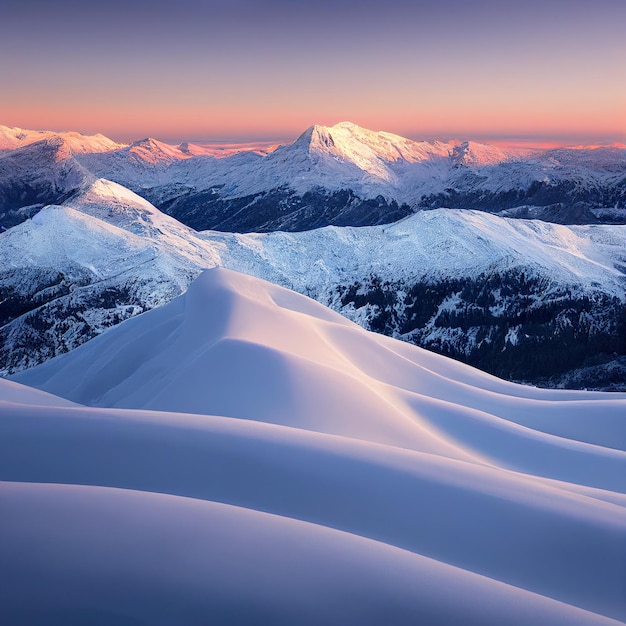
[6,269,626,626]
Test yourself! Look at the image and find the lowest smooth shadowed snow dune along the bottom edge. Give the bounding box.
[0,483,616,626]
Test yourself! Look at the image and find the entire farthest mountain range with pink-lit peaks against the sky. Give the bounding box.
[0,122,626,232]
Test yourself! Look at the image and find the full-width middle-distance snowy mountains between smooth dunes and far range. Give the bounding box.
[0,185,626,389]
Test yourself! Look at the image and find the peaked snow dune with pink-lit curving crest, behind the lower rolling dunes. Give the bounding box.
[14,268,626,470]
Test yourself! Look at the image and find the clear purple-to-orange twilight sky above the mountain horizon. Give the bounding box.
[0,0,626,144]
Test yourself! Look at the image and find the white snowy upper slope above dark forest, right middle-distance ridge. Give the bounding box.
[200,209,626,299]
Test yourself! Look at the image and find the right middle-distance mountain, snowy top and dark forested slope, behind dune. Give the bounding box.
[211,209,626,389]
